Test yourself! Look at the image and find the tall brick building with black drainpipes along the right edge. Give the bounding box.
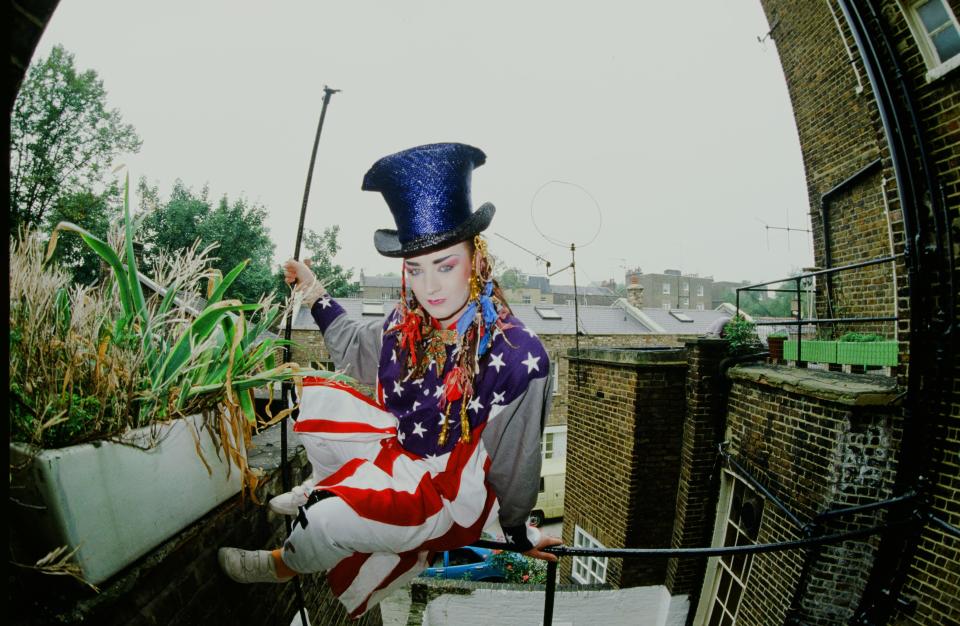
[761,0,960,624]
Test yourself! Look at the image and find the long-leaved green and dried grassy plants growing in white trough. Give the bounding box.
[10,176,331,494]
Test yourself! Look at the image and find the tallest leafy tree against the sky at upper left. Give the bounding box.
[10,46,141,229]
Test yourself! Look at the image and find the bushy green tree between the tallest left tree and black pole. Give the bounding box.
[139,180,274,302]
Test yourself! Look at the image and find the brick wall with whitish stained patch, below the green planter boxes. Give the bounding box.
[724,366,901,626]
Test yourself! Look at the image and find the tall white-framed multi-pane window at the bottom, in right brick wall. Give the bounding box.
[698,470,763,626]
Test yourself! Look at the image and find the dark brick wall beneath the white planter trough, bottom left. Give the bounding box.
[8,420,381,626]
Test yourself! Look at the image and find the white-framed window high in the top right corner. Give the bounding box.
[901,0,960,80]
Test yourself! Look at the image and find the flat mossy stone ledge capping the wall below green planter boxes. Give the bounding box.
[727,365,900,406]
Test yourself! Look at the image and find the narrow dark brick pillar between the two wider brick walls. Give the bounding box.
[666,339,728,606]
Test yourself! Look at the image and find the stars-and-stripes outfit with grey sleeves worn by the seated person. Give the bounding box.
[282,297,552,617]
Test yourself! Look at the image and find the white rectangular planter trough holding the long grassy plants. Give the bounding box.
[10,415,242,584]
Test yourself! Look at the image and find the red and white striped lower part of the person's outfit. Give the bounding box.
[283,378,497,617]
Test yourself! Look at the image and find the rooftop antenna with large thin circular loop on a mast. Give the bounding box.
[530,180,603,386]
